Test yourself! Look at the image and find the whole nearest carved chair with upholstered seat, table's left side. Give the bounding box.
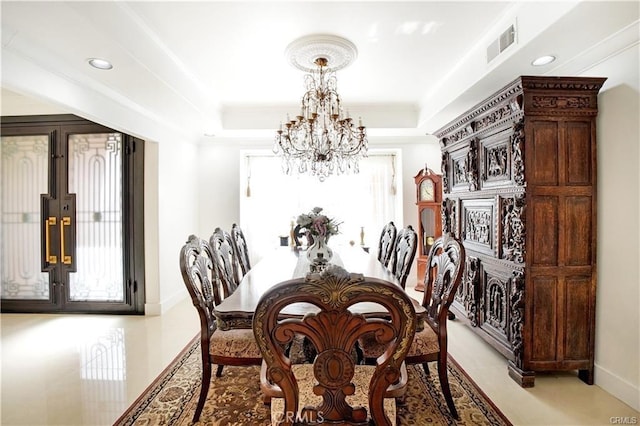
[180,235,262,422]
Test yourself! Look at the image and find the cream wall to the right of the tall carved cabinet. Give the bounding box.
[585,45,640,410]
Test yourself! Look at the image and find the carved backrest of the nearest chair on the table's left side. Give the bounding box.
[180,235,222,347]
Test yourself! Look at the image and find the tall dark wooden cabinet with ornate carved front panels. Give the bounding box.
[436,76,605,387]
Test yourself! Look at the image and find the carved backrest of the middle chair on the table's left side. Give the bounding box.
[209,228,240,298]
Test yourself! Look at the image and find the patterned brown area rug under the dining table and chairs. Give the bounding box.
[115,338,511,426]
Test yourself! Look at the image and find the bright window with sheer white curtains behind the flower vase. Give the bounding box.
[240,151,402,263]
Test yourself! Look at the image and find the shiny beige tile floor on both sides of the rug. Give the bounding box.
[0,282,640,426]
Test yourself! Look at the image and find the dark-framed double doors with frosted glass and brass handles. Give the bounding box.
[0,116,144,313]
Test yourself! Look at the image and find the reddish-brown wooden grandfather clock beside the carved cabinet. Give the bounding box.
[414,166,442,291]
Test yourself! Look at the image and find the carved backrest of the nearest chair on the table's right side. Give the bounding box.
[422,233,465,330]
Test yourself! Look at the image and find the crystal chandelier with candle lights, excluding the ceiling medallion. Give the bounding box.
[273,57,369,181]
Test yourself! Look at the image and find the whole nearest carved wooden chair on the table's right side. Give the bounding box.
[359,234,465,419]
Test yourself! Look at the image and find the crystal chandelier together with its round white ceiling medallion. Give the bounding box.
[273,35,368,181]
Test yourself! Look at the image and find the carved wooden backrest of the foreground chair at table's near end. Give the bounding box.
[253,265,417,425]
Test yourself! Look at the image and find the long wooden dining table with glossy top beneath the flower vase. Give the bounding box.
[213,246,426,330]
